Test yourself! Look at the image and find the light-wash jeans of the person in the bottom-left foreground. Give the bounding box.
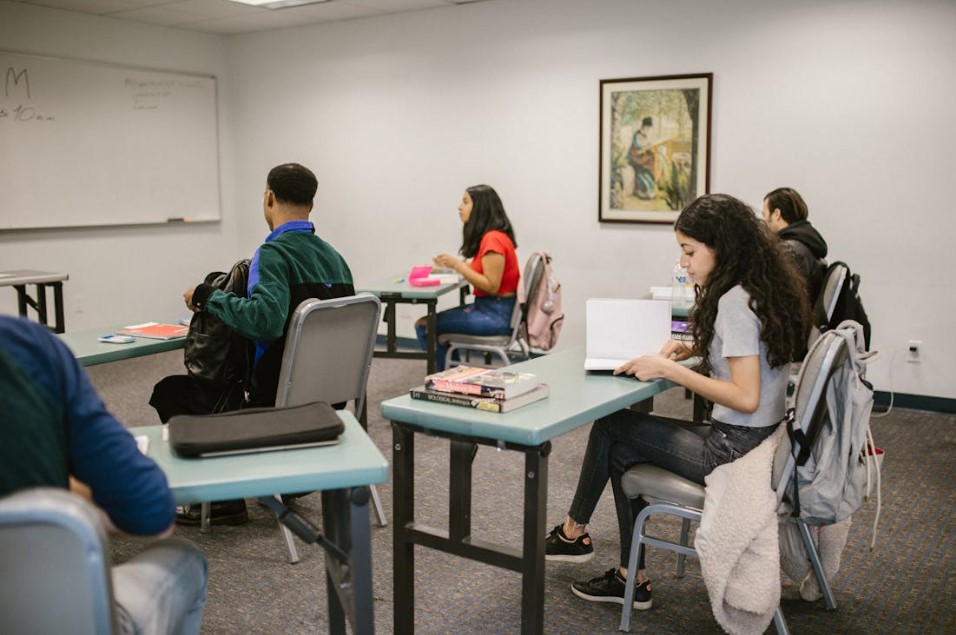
[113,537,208,635]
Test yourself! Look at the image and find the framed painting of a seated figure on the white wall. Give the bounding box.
[598,73,714,223]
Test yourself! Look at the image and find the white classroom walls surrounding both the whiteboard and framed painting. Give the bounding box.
[0,0,956,398]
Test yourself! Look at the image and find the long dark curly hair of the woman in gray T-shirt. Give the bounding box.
[674,194,810,372]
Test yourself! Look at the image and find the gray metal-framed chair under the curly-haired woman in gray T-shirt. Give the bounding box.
[620,332,847,635]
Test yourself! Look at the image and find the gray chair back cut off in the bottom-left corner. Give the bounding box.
[0,488,117,635]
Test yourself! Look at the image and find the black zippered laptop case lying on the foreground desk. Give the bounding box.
[169,401,345,457]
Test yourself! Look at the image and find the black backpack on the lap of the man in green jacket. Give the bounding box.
[183,259,252,412]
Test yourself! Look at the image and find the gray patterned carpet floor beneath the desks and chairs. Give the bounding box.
[88,352,956,634]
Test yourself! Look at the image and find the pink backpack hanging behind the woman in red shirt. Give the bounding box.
[521,251,564,351]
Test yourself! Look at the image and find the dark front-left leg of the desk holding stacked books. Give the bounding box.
[392,422,415,635]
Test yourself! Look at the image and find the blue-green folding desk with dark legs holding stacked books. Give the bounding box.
[382,348,674,634]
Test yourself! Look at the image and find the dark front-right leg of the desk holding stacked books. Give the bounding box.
[521,442,551,635]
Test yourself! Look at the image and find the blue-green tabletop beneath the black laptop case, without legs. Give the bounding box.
[130,410,388,505]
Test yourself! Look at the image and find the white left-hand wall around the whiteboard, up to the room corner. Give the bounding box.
[0,2,240,330]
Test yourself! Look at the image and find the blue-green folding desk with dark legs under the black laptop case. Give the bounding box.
[130,418,388,634]
